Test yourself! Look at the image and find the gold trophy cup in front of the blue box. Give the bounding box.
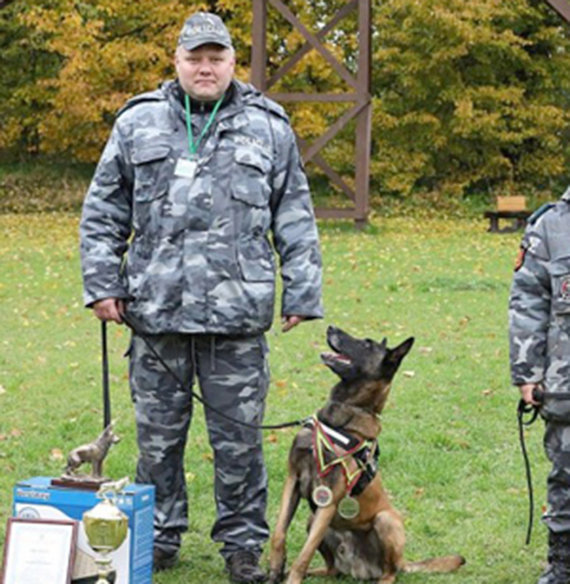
[83,477,129,584]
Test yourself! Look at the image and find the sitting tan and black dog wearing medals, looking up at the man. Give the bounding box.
[269,327,465,584]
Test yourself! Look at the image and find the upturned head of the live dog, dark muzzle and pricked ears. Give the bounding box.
[321,326,414,413]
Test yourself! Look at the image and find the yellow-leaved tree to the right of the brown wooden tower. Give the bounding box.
[373,0,570,195]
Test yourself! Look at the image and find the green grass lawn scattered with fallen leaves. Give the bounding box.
[0,214,548,584]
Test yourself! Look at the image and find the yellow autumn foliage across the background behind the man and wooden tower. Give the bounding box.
[0,0,570,197]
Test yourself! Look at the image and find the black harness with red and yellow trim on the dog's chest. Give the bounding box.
[305,414,380,496]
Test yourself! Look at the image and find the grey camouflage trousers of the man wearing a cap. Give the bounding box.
[130,334,269,557]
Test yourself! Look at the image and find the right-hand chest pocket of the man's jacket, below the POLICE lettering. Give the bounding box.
[232,147,271,207]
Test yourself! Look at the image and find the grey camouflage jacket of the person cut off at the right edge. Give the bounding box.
[509,189,570,421]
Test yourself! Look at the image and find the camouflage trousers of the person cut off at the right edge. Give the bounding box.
[542,421,570,533]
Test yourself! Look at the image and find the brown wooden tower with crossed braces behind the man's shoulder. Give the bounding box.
[251,0,372,225]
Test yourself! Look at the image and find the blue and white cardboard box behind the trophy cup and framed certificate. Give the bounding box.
[13,477,154,584]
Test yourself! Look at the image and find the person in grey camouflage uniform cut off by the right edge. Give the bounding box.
[509,189,570,584]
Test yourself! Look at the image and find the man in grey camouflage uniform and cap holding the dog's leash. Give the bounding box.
[80,13,322,582]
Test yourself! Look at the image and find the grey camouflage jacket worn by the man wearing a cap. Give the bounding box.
[80,81,322,335]
